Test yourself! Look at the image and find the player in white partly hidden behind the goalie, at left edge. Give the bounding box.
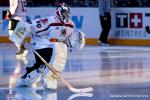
[6,0,28,56]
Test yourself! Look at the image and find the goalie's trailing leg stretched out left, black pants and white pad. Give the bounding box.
[17,48,52,86]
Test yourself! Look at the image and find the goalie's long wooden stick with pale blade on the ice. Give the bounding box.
[16,22,93,93]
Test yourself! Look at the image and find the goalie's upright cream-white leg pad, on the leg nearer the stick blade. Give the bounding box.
[41,42,67,90]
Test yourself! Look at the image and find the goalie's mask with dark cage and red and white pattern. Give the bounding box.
[55,3,70,22]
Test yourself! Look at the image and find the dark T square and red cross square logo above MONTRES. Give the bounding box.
[116,13,143,28]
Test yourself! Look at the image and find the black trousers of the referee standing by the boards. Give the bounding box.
[99,13,111,43]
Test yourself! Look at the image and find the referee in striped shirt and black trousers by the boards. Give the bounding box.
[99,0,112,46]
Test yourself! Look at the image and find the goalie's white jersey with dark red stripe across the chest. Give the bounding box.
[31,16,74,49]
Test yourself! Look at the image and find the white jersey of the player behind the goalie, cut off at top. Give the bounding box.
[9,0,27,17]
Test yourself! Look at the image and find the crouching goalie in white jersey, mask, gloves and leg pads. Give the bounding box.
[12,3,85,89]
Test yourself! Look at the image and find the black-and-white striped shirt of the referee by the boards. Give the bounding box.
[99,0,112,16]
